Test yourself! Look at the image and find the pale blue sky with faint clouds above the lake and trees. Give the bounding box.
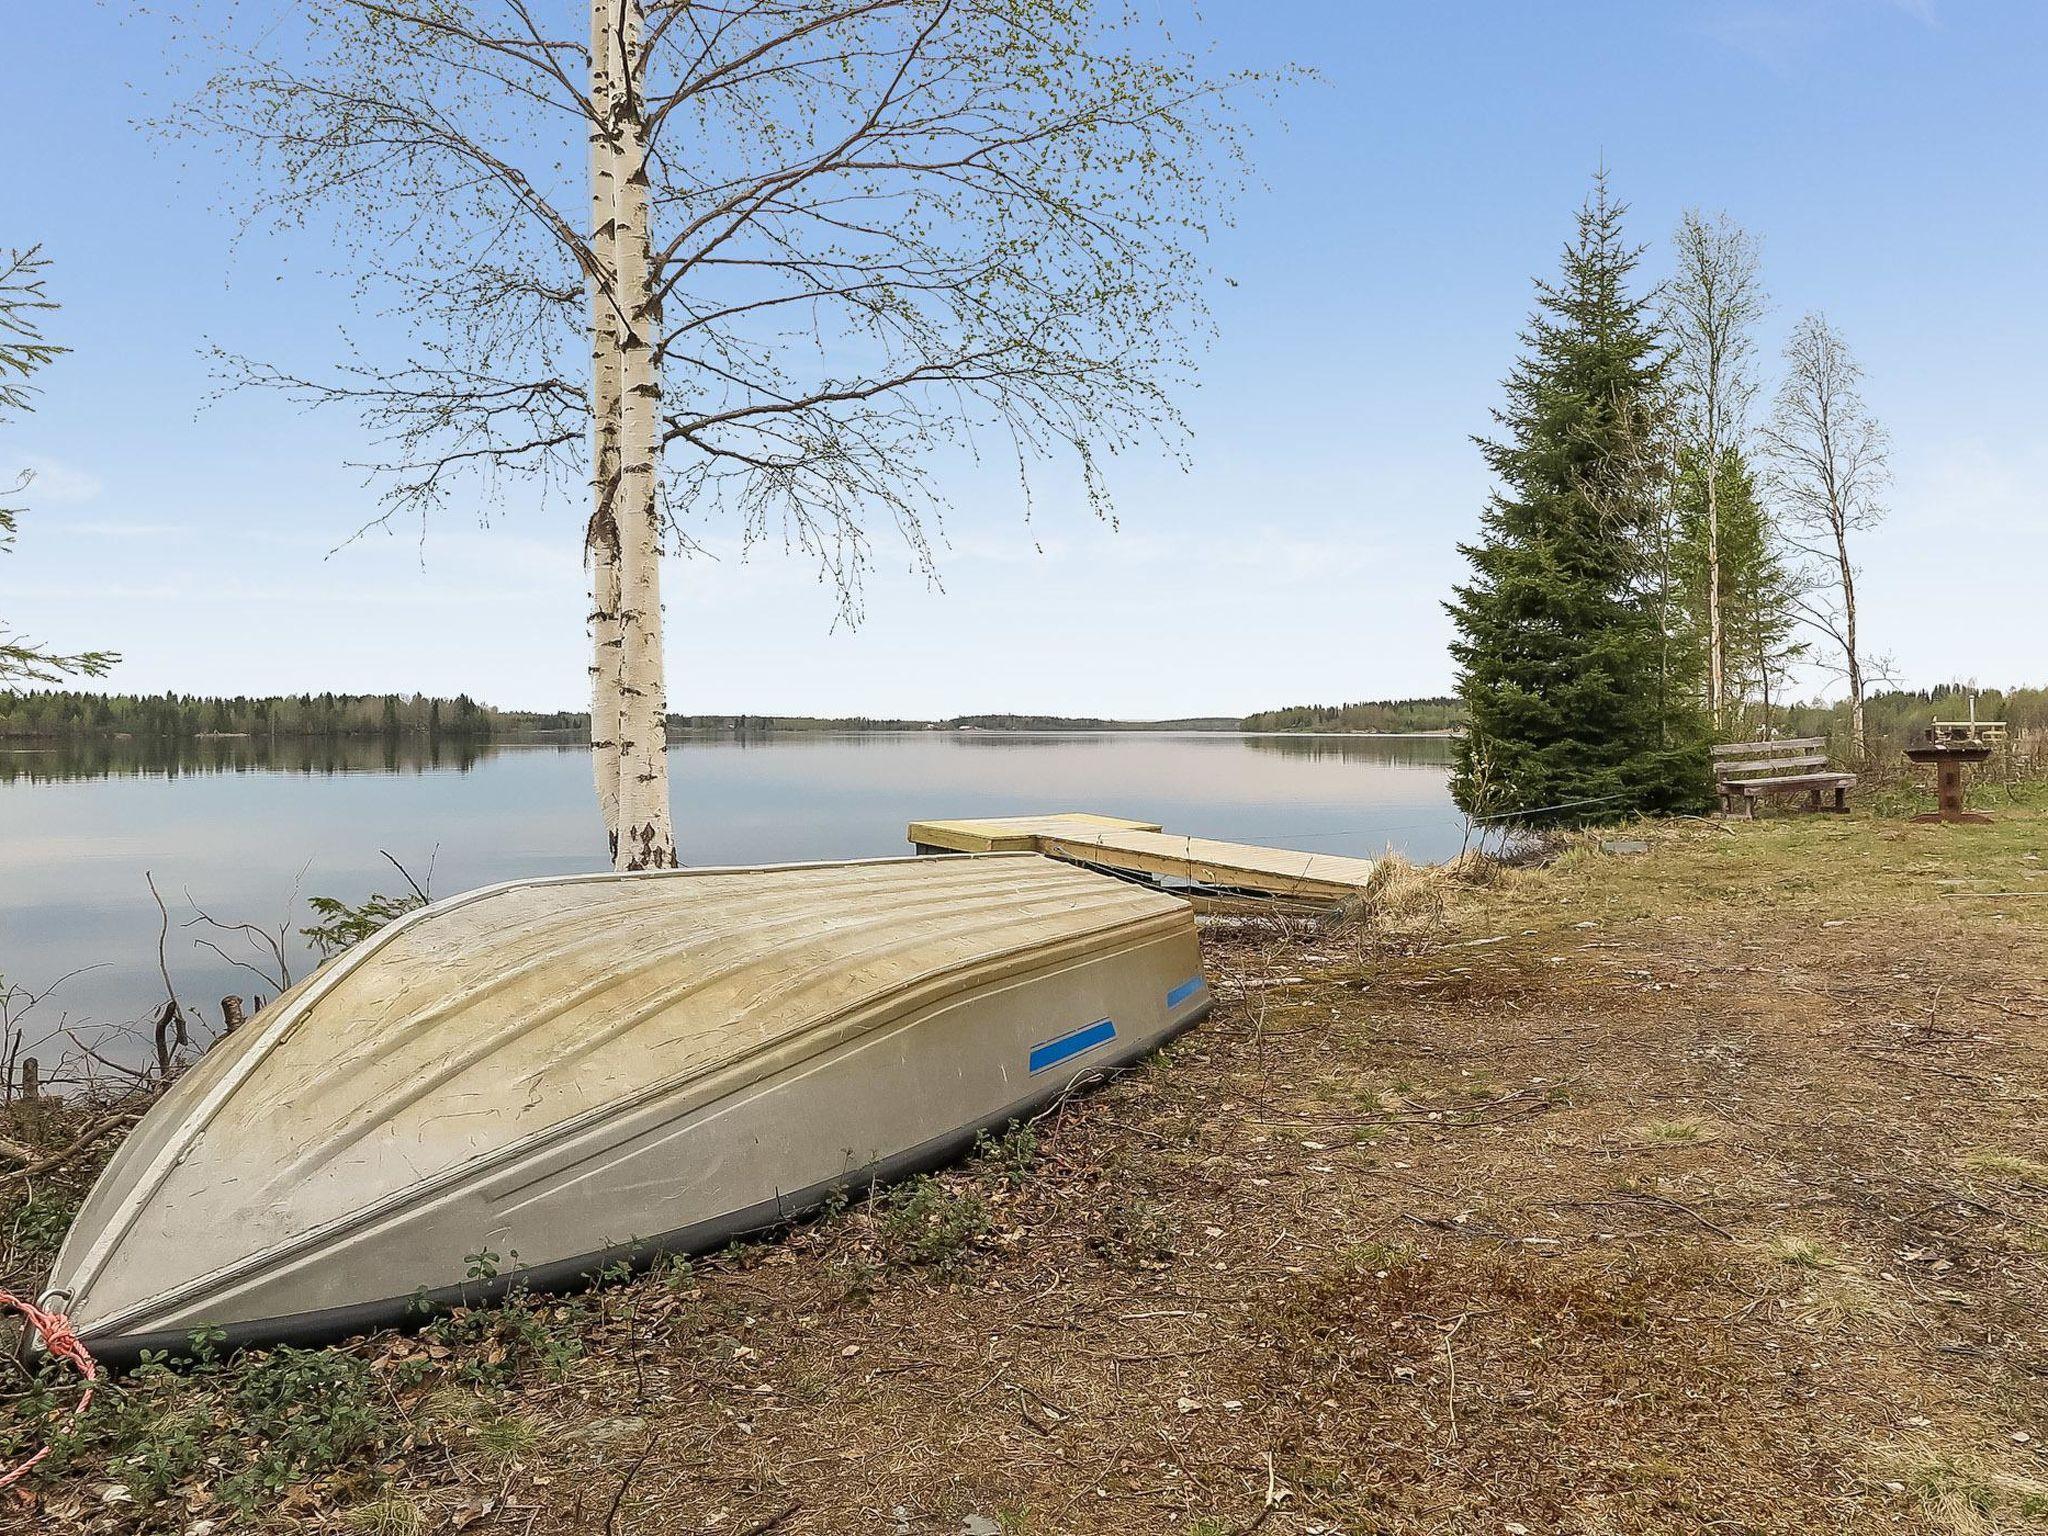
[0,0,2048,719]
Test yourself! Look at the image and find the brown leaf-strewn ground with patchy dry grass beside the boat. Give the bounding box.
[0,809,2048,1536]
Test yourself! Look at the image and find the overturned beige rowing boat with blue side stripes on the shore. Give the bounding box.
[45,854,1210,1364]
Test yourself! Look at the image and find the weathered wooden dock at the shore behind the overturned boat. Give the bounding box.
[909,811,1376,911]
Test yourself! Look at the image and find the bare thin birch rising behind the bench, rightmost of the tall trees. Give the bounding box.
[1763,311,1890,754]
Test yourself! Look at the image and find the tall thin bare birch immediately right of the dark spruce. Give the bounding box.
[1665,209,1767,729]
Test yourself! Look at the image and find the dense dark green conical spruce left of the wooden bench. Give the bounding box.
[1448,174,1708,823]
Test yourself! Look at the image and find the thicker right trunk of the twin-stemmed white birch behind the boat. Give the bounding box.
[614,0,676,870]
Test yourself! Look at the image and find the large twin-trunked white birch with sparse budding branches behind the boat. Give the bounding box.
[180,0,1264,868]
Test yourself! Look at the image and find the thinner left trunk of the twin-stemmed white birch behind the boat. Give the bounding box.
[584,0,621,862]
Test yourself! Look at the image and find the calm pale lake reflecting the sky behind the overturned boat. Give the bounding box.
[0,731,1464,1059]
